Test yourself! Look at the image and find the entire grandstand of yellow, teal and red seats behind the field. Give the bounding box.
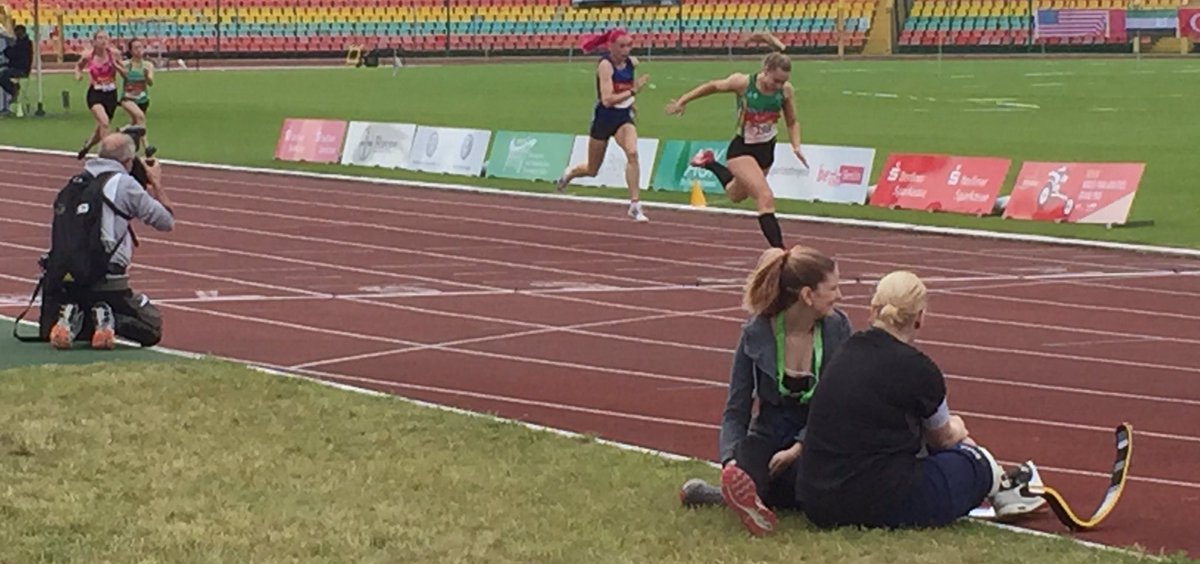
[0,0,1187,58]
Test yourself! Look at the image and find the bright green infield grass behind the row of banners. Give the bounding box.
[0,58,1200,247]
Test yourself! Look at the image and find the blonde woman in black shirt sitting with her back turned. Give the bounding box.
[721,271,1045,534]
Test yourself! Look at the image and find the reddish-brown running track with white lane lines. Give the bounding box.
[0,148,1200,556]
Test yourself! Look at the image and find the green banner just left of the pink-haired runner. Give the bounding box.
[487,131,575,181]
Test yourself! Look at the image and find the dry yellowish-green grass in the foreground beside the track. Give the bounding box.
[0,360,1182,564]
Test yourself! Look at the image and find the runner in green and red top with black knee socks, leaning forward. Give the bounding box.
[667,44,809,248]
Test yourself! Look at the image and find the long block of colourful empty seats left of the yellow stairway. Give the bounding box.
[10,0,875,53]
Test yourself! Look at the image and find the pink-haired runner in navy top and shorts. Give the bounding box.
[556,29,650,221]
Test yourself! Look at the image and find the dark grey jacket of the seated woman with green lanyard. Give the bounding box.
[720,310,853,463]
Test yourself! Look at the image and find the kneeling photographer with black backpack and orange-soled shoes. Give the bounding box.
[41,128,175,349]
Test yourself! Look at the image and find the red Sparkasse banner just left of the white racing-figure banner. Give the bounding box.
[871,154,1012,215]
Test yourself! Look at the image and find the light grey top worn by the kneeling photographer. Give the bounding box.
[84,158,175,274]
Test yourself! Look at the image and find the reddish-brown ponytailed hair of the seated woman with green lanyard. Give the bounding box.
[742,245,836,317]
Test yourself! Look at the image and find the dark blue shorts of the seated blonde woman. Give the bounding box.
[884,444,992,528]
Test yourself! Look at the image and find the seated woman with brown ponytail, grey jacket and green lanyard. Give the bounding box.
[679,246,853,509]
